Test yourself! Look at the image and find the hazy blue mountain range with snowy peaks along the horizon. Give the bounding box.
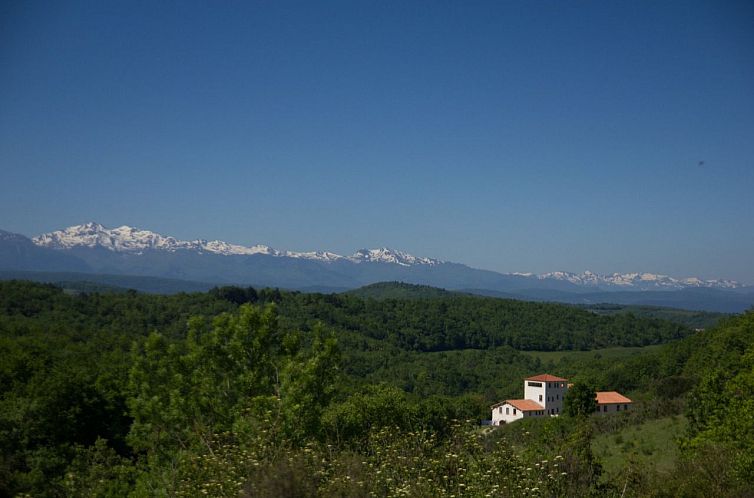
[0,223,754,311]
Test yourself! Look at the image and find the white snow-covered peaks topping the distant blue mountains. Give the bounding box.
[32,222,741,290]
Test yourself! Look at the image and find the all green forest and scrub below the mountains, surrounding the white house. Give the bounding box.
[0,281,754,497]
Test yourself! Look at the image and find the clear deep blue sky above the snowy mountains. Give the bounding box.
[0,1,754,283]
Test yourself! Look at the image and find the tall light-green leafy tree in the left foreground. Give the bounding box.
[128,304,279,454]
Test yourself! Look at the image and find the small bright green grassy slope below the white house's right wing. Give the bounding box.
[592,415,686,477]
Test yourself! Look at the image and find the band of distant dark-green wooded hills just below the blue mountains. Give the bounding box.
[0,281,692,352]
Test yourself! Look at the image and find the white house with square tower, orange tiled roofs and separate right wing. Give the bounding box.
[491,374,632,425]
